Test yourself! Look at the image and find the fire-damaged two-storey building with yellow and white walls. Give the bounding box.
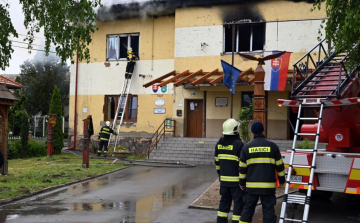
[69,0,326,151]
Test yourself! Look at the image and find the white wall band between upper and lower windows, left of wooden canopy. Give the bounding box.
[70,59,174,95]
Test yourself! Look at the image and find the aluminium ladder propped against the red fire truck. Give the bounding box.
[279,98,324,223]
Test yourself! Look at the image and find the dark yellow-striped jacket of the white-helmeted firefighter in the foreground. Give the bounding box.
[215,135,244,187]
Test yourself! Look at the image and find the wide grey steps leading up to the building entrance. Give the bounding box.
[149,137,326,165]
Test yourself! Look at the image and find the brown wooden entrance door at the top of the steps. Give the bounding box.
[186,100,203,138]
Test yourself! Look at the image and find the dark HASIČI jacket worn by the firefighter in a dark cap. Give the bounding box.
[240,134,285,195]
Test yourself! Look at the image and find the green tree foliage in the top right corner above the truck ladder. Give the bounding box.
[312,0,360,67]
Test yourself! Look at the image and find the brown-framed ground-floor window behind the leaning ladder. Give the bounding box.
[104,95,138,122]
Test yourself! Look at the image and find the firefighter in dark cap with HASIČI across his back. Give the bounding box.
[240,121,285,223]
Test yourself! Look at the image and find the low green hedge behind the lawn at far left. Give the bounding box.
[8,140,46,159]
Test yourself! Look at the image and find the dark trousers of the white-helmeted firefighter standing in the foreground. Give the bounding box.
[216,186,244,223]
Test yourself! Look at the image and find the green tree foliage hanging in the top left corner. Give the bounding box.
[0,0,101,70]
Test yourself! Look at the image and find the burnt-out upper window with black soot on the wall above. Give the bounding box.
[224,23,265,52]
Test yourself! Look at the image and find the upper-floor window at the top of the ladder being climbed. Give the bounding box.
[106,33,140,60]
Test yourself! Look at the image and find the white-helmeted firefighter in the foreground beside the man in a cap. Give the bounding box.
[215,118,244,223]
